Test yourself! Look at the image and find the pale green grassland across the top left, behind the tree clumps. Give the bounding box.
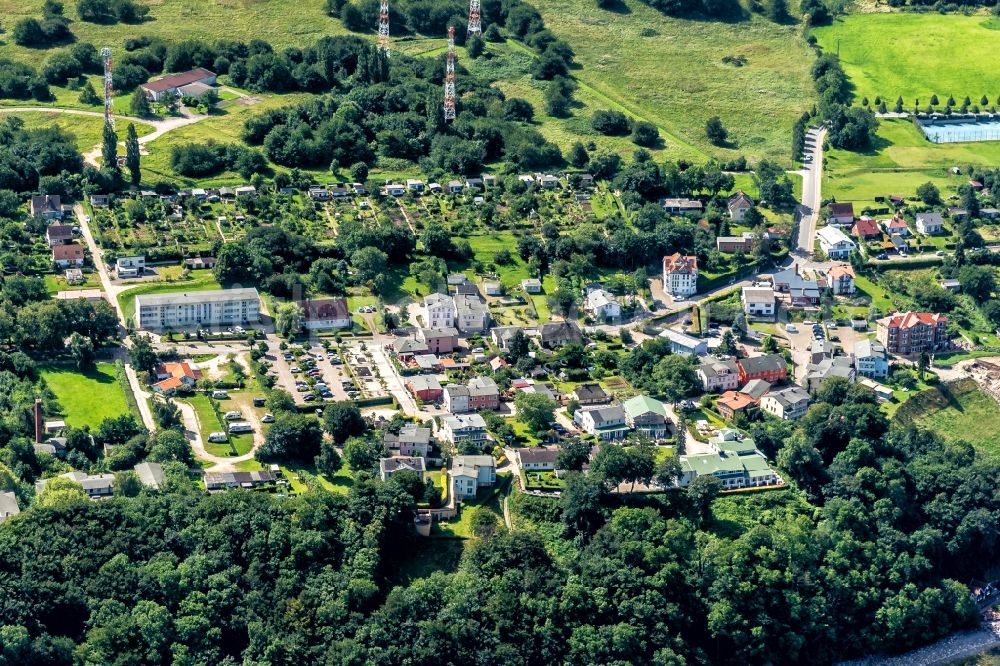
[0,0,346,65]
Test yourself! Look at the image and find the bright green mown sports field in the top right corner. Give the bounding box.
[813,12,1000,104]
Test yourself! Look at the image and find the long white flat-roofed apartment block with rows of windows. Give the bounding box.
[135,289,260,330]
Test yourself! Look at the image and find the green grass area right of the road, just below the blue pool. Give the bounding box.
[823,119,1000,204]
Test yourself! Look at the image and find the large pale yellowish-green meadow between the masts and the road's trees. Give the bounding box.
[536,0,816,161]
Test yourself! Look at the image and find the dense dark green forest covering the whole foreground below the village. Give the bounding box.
[0,375,1000,665]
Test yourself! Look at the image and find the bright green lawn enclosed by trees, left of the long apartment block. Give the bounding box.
[41,363,129,428]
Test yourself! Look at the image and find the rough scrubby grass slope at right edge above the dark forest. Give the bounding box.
[895,380,1000,459]
